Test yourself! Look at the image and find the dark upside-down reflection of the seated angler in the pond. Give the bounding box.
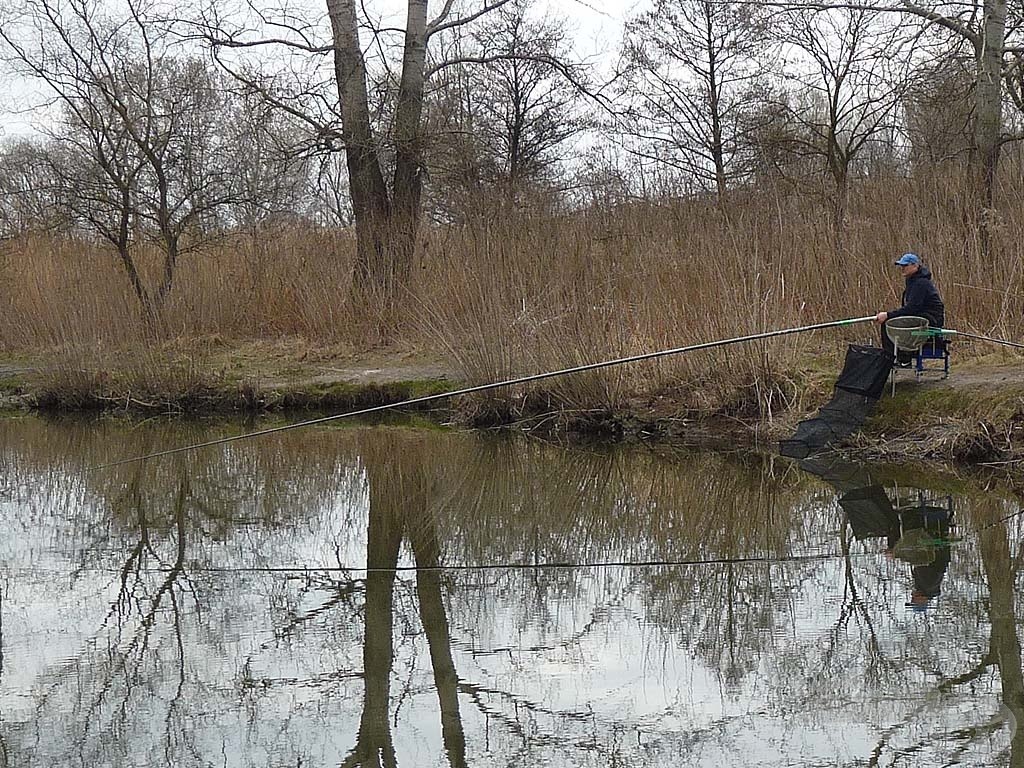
[886,500,952,611]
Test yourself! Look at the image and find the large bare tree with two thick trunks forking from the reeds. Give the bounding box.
[194,0,528,330]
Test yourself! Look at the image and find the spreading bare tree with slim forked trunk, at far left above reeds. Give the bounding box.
[0,0,253,325]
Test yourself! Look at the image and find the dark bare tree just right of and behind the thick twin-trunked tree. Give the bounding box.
[415,0,586,218]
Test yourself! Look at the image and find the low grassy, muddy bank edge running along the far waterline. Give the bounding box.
[0,364,1024,465]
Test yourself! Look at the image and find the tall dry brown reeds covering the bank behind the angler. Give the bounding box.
[0,167,1024,416]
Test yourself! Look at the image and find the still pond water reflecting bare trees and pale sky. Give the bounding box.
[0,419,1024,767]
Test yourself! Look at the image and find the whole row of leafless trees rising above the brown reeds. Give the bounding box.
[6,0,1024,339]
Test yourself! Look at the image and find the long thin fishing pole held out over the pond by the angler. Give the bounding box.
[91,314,874,469]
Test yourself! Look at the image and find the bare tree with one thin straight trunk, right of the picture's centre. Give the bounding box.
[622,0,768,200]
